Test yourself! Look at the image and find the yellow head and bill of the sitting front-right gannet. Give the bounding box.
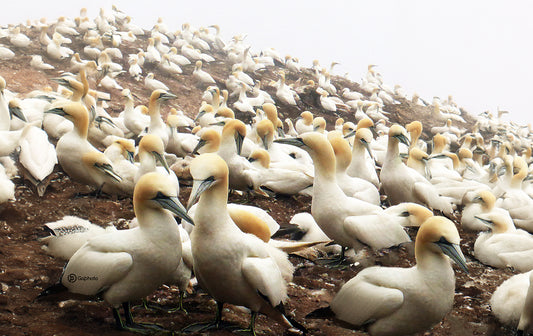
[415,216,468,273]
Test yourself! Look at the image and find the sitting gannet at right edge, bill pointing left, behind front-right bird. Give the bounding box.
[474,213,533,272]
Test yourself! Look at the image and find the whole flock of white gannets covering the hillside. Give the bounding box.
[0,6,533,335]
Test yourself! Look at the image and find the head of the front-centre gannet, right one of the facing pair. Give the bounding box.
[187,153,228,208]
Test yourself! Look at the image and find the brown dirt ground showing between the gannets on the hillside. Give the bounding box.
[0,21,516,336]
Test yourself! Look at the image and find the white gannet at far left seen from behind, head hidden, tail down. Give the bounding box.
[19,126,57,197]
